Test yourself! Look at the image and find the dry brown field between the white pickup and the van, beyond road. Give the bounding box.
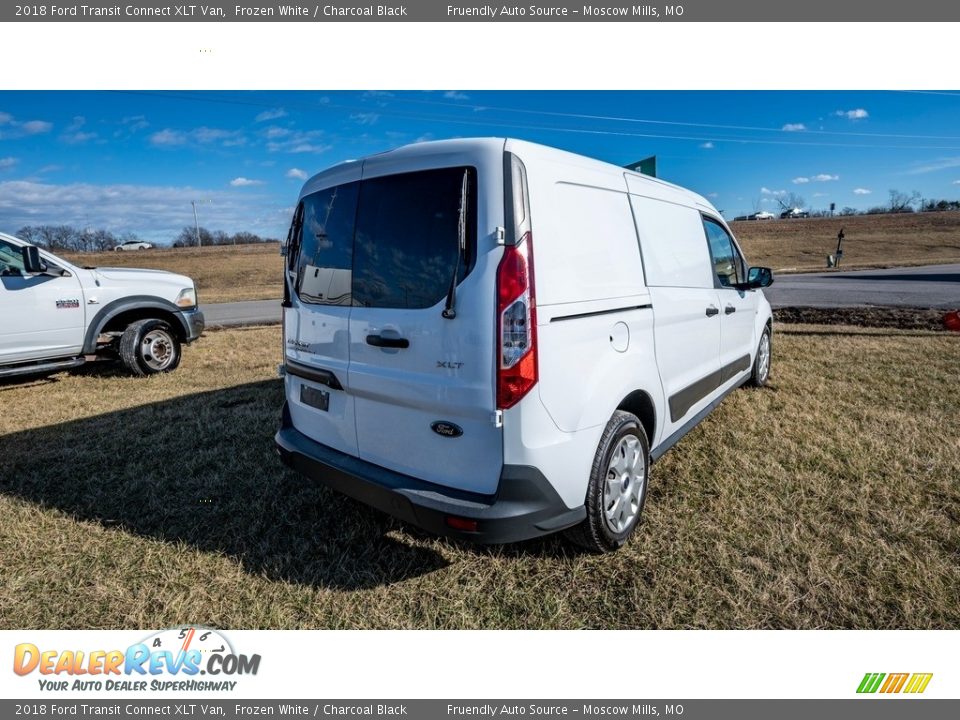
[64,243,283,304]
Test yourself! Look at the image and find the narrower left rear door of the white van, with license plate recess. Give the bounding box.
[284,163,361,456]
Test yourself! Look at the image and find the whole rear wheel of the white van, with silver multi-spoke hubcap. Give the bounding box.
[568,410,650,552]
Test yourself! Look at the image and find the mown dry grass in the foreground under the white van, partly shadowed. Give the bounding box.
[0,325,960,629]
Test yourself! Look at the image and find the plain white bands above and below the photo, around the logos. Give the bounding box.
[0,16,960,701]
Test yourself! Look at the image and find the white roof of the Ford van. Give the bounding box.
[304,137,719,215]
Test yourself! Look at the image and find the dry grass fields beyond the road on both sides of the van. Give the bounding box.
[58,212,960,303]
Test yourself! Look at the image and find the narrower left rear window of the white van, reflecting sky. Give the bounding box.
[294,182,360,305]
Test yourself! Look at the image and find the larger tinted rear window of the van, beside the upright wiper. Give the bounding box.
[353,167,477,309]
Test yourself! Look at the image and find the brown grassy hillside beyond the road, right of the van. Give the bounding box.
[731,212,960,272]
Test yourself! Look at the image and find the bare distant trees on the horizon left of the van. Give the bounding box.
[16,225,277,252]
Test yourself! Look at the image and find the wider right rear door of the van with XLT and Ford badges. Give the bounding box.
[349,160,503,494]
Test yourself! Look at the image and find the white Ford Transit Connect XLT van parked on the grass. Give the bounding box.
[276,138,772,551]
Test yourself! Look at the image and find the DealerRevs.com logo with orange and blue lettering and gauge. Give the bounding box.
[13,627,260,692]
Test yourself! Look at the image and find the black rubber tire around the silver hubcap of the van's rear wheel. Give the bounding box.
[567,410,650,553]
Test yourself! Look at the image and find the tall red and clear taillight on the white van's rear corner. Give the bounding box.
[497,232,537,410]
